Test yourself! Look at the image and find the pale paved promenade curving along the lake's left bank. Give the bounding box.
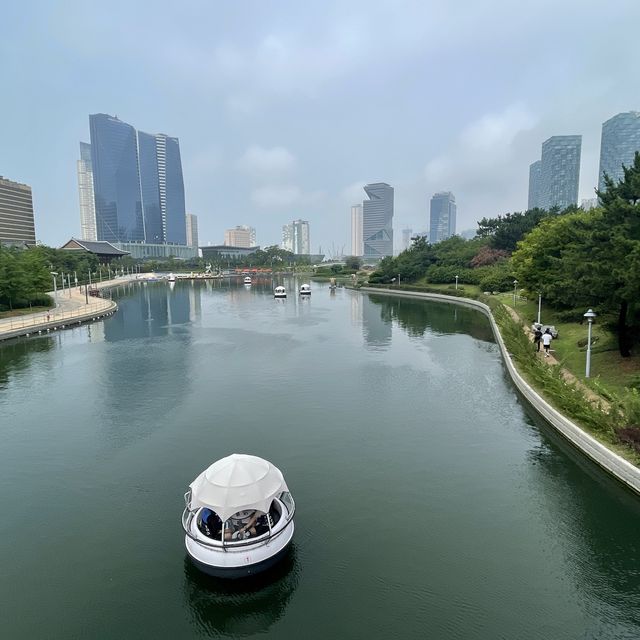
[0,276,135,340]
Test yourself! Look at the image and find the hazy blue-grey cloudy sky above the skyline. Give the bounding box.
[0,0,640,253]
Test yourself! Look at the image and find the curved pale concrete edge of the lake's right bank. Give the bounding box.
[358,287,640,495]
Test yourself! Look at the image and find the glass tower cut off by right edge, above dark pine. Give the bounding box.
[598,111,640,191]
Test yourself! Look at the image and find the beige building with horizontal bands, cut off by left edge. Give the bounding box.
[0,176,36,245]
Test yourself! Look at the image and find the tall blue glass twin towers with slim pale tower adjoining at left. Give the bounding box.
[78,113,187,245]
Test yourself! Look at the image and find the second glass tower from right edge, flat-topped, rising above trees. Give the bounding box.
[538,136,582,209]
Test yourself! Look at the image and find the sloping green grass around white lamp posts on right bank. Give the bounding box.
[496,293,640,393]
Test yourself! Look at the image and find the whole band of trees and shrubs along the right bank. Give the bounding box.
[369,153,640,357]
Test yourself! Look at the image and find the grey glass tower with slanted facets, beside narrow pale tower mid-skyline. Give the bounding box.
[362,182,393,259]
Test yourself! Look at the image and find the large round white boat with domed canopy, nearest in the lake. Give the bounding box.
[182,453,295,578]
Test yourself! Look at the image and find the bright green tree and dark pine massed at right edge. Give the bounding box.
[512,154,640,357]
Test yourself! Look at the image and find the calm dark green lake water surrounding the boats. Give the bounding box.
[0,280,640,640]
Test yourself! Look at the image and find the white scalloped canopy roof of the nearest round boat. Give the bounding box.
[189,453,289,522]
